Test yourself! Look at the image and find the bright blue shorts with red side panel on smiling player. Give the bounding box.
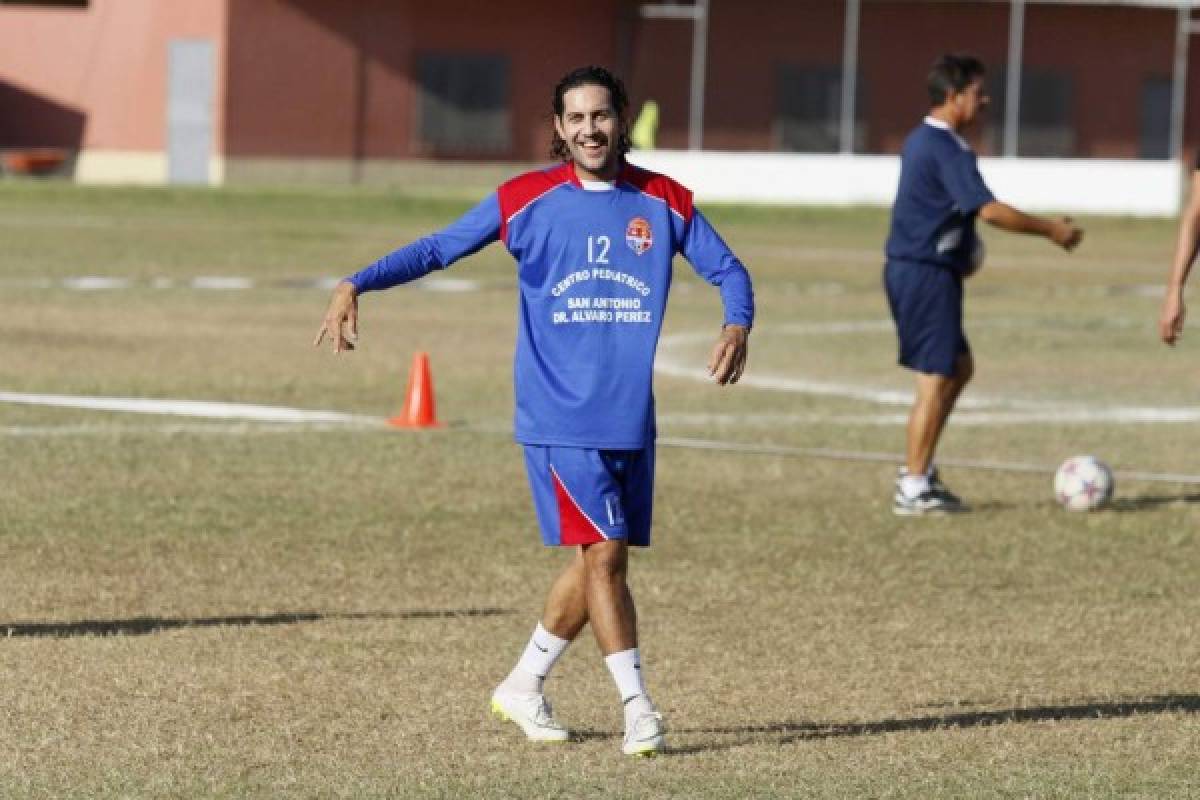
[524,445,654,547]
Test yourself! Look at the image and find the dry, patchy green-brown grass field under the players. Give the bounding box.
[0,182,1200,798]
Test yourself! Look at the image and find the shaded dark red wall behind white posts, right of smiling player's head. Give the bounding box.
[630,0,1180,157]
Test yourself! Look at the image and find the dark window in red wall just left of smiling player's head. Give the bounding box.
[416,53,512,156]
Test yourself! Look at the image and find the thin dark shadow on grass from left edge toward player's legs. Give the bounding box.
[0,608,515,637]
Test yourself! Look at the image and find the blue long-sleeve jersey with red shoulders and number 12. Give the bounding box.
[348,163,754,450]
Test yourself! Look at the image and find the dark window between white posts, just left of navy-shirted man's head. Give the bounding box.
[773,64,865,152]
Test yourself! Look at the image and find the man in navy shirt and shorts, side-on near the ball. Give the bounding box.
[883,55,1084,516]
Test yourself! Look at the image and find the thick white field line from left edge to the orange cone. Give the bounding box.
[0,392,383,425]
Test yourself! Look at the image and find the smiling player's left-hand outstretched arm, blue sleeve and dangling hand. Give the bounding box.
[313,194,500,353]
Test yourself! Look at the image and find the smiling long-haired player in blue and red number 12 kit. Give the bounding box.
[314,66,754,754]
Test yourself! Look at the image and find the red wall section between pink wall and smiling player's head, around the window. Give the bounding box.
[227,0,623,160]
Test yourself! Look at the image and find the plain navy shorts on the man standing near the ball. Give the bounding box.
[883,261,971,378]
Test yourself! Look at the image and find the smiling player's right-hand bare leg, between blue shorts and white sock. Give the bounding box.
[581,540,637,656]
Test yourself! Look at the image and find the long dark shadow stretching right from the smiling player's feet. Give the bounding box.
[667,694,1200,756]
